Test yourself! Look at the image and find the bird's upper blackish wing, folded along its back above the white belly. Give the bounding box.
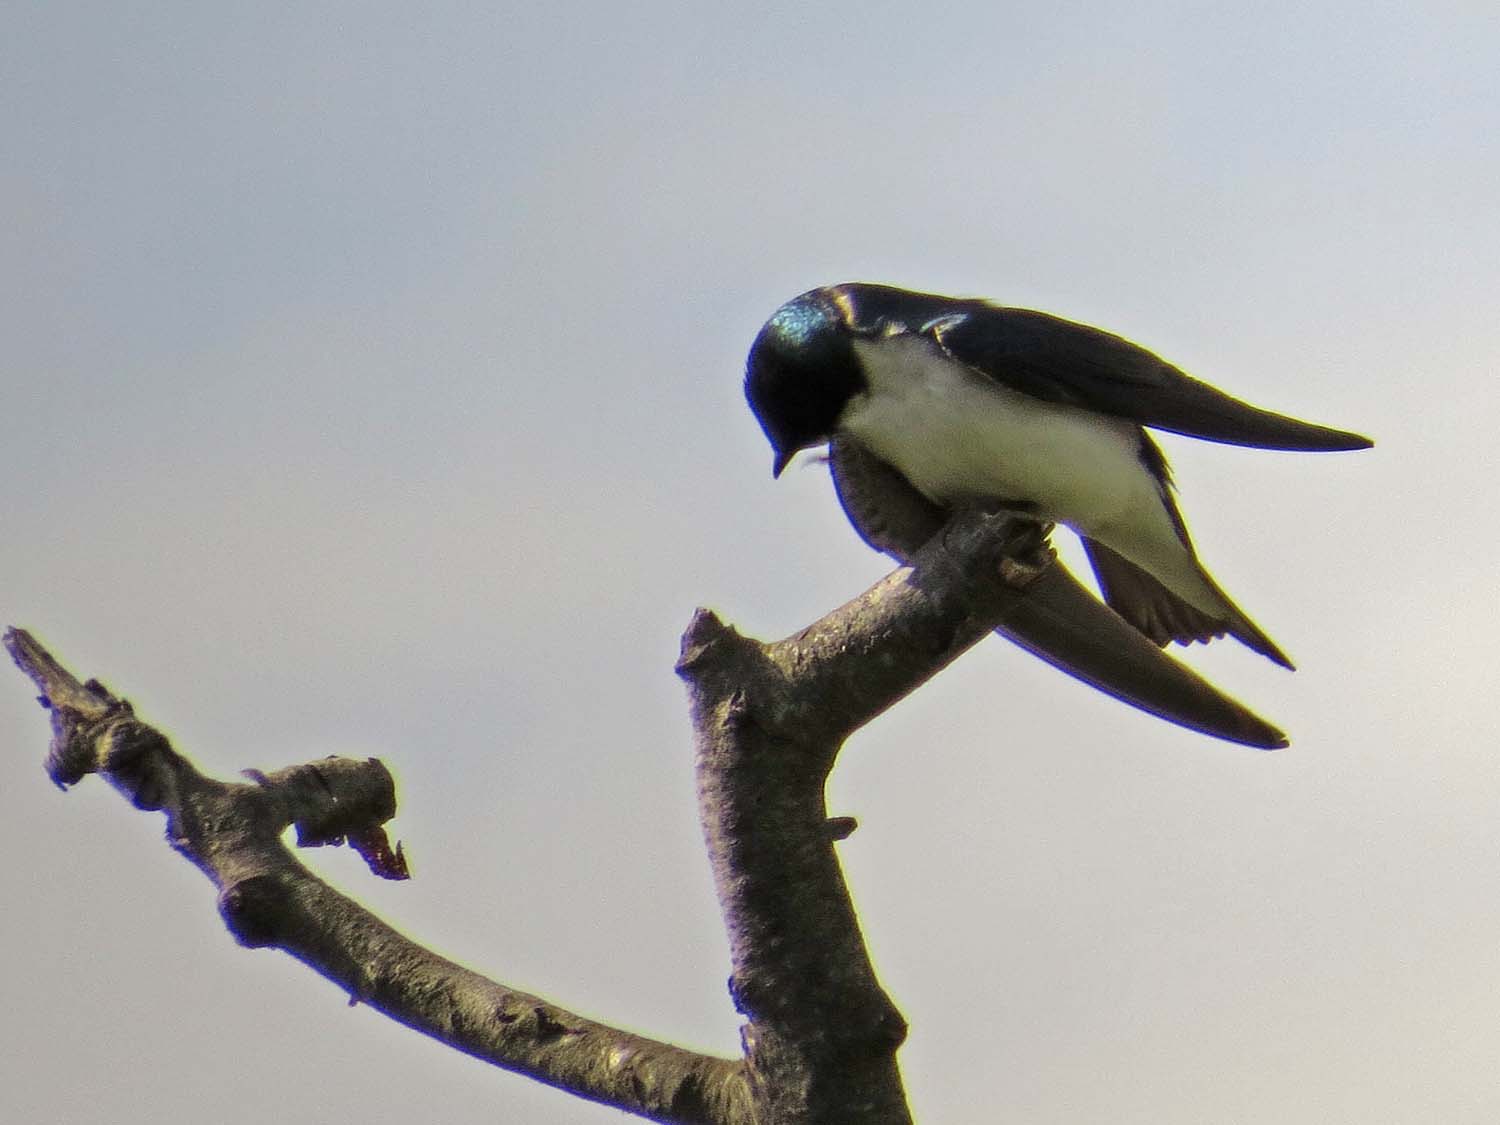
[833,284,1373,450]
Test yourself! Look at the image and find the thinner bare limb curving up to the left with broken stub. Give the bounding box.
[5,629,752,1125]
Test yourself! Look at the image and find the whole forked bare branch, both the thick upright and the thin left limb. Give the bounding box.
[5,513,1050,1125]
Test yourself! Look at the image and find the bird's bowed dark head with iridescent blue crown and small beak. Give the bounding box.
[746,288,866,477]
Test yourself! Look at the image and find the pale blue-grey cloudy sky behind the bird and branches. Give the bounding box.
[0,2,1500,1125]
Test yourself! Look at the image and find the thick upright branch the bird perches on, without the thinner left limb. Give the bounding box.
[678,513,1040,1125]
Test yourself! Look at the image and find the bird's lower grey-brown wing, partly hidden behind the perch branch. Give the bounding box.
[830,437,1287,750]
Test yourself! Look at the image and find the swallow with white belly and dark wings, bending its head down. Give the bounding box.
[746,282,1373,744]
